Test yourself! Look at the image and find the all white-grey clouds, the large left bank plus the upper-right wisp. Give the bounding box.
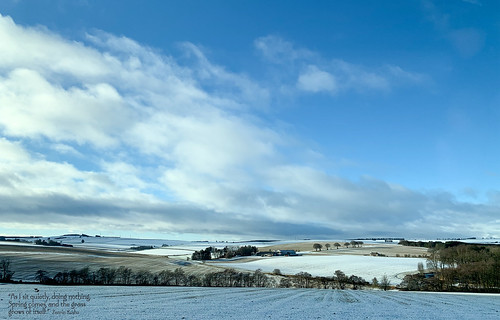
[0,16,500,238]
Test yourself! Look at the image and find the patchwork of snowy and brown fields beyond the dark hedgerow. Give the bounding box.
[0,236,496,285]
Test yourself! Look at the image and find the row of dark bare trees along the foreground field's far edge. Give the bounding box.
[0,259,390,290]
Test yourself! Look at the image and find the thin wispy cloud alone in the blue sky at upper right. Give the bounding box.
[254,36,424,95]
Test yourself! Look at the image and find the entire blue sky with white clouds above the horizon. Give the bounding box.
[0,0,500,240]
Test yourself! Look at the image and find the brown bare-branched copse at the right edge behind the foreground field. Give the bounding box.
[400,240,500,292]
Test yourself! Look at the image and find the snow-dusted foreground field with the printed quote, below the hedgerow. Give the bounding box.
[0,285,500,320]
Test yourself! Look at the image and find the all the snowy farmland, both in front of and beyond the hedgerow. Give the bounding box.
[0,238,500,320]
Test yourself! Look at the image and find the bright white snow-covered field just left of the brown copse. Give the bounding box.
[213,255,425,284]
